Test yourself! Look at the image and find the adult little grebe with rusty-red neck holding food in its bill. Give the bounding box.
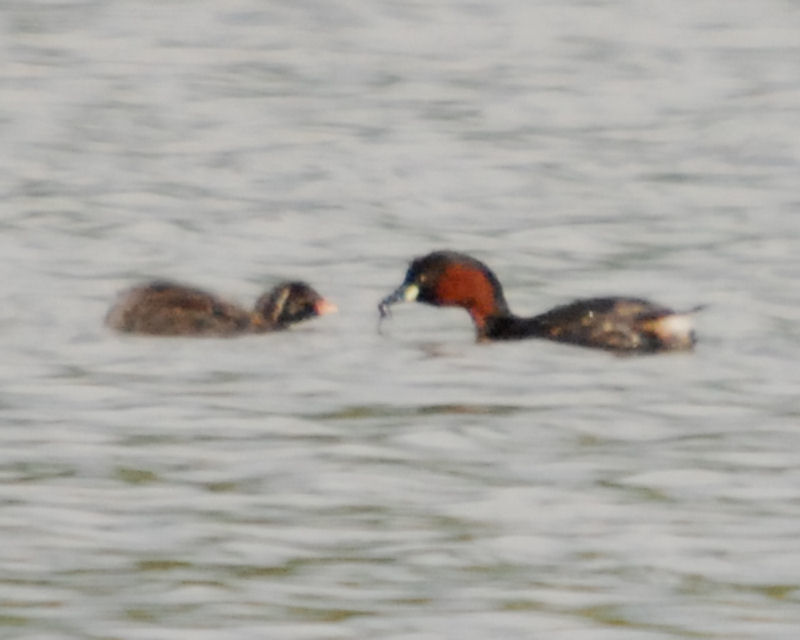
[378,251,695,353]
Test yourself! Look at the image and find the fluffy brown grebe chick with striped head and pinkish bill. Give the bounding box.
[106,280,336,336]
